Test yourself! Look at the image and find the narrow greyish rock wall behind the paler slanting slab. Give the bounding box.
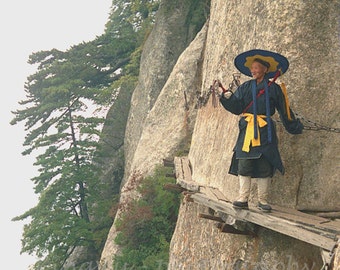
[124,0,206,188]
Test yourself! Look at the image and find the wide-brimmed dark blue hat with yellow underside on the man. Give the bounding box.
[234,49,289,78]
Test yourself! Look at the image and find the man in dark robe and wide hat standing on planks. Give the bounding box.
[220,50,303,212]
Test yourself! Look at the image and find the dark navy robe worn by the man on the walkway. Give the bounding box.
[220,79,303,177]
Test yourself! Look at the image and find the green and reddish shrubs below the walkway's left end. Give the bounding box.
[114,167,180,270]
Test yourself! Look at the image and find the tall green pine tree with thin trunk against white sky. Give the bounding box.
[12,44,109,269]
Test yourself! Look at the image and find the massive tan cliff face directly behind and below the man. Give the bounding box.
[169,0,340,270]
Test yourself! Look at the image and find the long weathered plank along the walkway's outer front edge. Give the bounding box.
[191,193,337,251]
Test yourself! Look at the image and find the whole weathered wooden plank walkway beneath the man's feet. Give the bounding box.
[174,157,340,251]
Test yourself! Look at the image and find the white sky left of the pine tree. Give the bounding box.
[0,0,112,270]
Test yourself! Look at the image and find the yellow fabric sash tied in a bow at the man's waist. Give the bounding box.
[242,113,267,152]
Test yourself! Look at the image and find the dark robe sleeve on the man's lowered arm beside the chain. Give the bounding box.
[275,84,303,134]
